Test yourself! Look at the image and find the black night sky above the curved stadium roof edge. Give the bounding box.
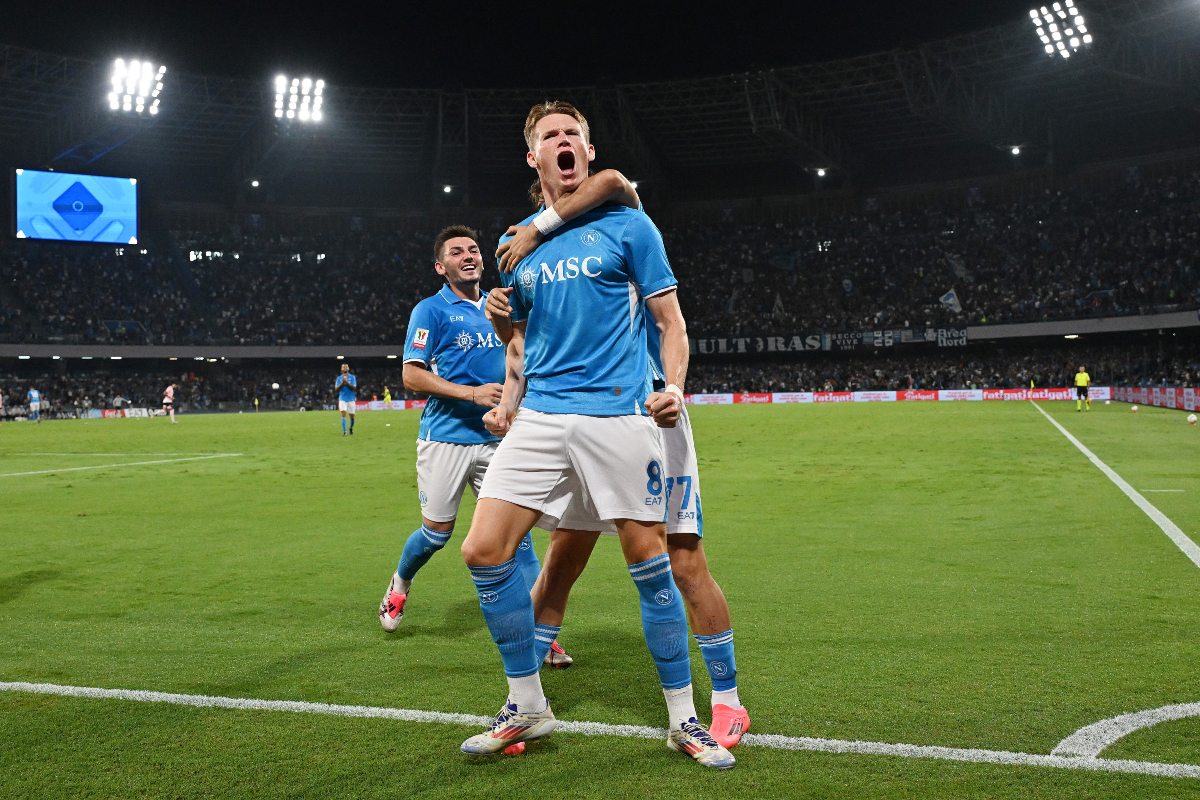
[9,0,1030,88]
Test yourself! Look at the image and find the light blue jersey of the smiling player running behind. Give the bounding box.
[404,287,504,445]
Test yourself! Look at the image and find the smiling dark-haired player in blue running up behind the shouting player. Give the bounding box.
[379,225,552,666]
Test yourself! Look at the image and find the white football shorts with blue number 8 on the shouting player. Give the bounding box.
[479,408,667,530]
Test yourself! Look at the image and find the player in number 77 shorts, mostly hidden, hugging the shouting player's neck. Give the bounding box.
[484,170,750,747]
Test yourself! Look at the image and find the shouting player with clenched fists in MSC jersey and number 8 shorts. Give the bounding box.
[462,103,734,768]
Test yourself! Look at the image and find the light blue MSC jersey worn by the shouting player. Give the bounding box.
[502,206,677,416]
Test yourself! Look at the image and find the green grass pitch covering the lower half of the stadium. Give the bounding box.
[0,402,1200,800]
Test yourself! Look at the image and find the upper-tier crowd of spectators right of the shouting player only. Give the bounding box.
[664,173,1200,336]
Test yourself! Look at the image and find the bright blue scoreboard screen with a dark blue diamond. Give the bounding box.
[14,169,138,245]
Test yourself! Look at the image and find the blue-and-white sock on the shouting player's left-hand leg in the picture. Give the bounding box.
[470,559,546,711]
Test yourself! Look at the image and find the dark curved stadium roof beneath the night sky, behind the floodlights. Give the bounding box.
[0,0,1200,203]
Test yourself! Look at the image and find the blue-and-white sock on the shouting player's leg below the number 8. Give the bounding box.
[629,553,696,730]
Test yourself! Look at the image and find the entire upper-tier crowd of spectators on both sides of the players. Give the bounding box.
[0,173,1200,344]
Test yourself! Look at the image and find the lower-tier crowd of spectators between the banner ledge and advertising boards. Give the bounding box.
[0,347,1200,419]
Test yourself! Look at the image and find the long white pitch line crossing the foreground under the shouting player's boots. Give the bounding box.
[0,681,1200,778]
